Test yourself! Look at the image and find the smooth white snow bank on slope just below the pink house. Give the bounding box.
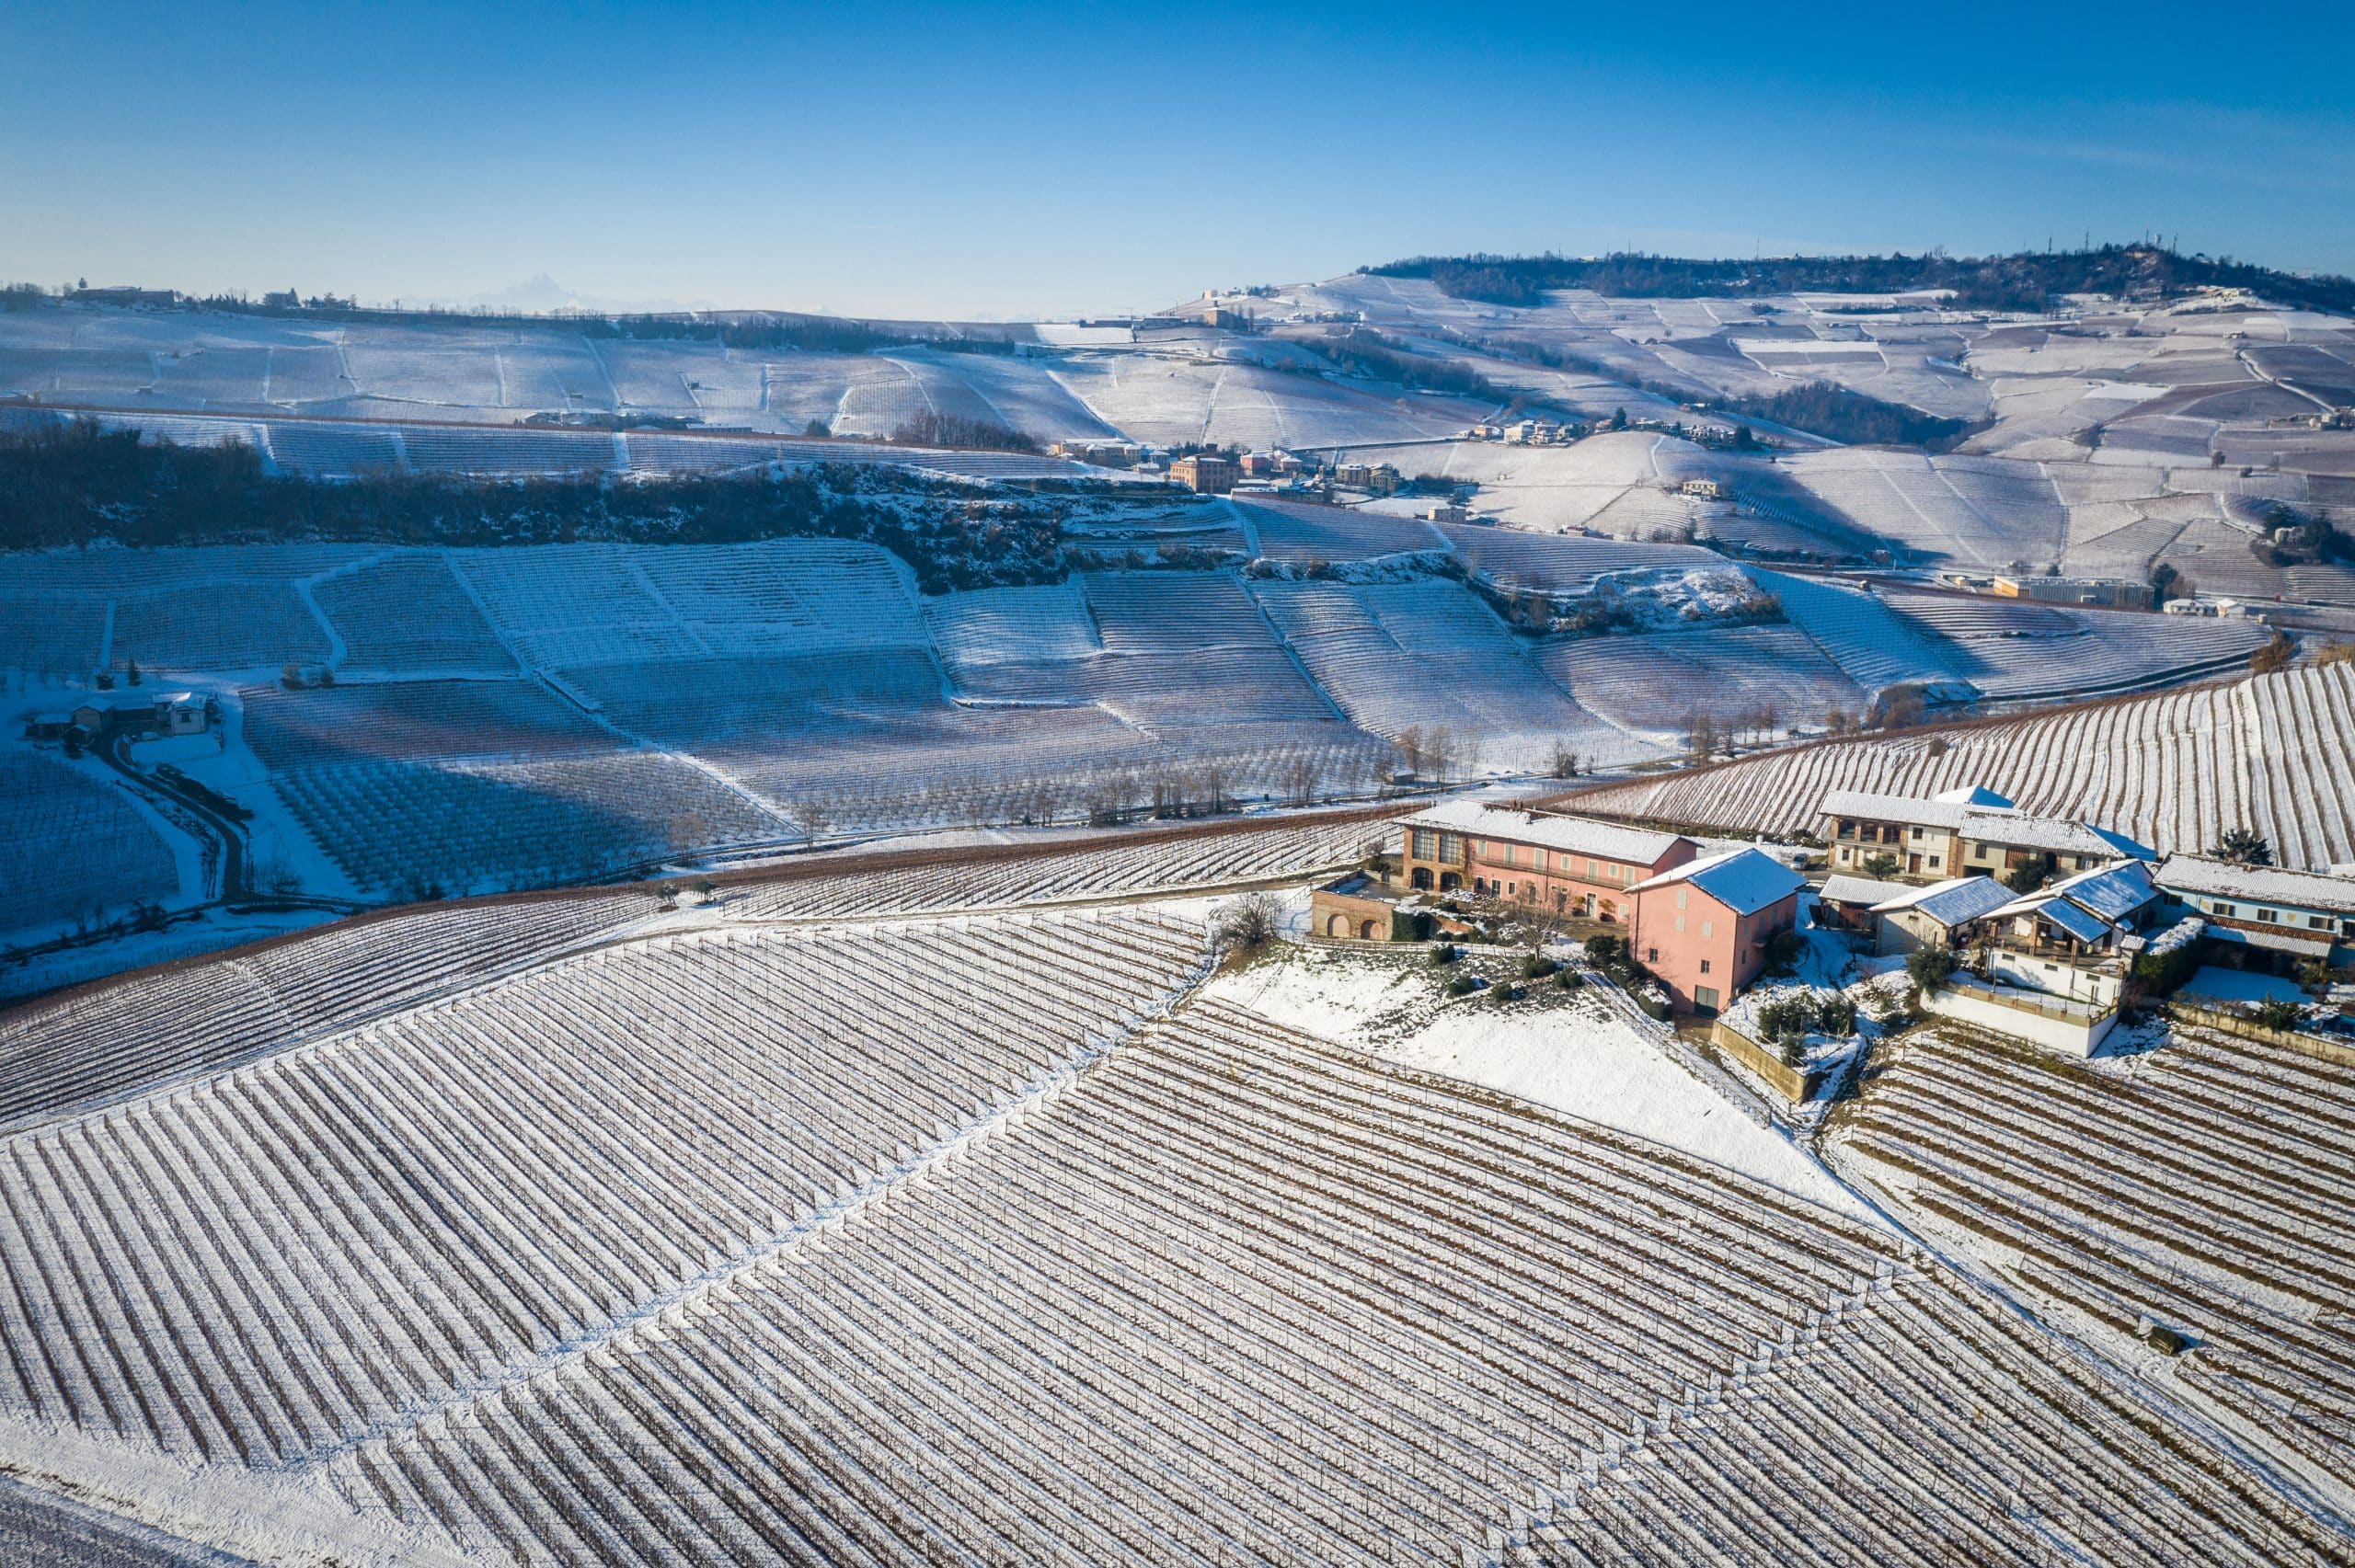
[1203,946,1858,1212]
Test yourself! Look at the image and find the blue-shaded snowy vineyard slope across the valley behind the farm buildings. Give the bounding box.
[0,524,2263,930]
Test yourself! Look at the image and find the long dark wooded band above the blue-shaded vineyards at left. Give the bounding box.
[0,419,1067,593]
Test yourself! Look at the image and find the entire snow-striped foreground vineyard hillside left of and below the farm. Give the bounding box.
[0,861,2348,1565]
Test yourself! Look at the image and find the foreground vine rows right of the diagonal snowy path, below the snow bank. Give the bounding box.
[332,1005,2334,1563]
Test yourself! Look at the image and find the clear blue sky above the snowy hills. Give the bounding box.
[0,0,2355,315]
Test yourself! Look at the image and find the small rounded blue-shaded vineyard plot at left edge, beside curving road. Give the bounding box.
[0,744,179,933]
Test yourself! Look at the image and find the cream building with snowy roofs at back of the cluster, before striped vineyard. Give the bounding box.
[1816,786,2157,883]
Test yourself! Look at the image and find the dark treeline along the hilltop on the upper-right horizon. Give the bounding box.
[1363,245,2355,311]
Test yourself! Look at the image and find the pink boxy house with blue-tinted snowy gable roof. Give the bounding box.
[1627,850,1807,1014]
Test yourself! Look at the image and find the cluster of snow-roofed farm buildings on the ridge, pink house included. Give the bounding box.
[1312,789,2355,1050]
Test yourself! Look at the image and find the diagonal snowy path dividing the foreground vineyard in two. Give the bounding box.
[305,918,1215,1471]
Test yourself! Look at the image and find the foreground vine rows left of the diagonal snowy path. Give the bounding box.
[0,913,1203,1478]
